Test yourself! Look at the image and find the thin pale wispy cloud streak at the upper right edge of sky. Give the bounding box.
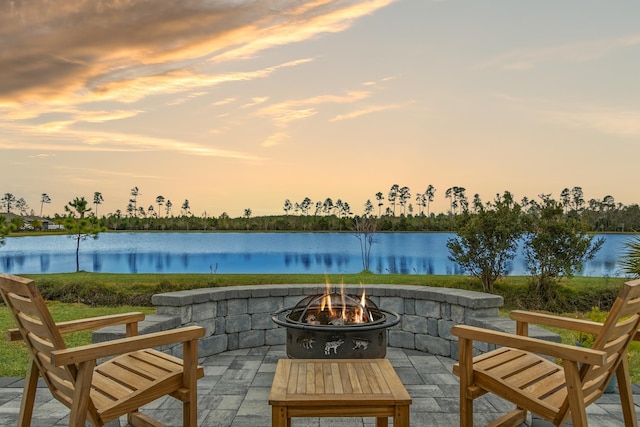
[477,34,640,70]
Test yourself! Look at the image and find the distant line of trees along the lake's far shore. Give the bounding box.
[0,184,640,236]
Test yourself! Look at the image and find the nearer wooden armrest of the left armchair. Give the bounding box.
[51,326,205,366]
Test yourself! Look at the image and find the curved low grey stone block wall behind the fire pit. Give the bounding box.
[93,285,559,358]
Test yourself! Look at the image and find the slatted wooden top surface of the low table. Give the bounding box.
[269,359,411,406]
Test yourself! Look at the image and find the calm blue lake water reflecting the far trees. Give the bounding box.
[0,233,631,277]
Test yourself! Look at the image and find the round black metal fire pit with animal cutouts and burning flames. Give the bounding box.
[272,291,400,359]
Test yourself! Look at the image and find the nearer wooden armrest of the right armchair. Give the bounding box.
[451,325,607,366]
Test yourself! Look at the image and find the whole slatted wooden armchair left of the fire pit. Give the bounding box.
[0,274,204,427]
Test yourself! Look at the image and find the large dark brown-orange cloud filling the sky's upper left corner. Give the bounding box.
[0,0,394,107]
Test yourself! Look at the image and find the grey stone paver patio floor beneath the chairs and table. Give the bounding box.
[0,346,640,427]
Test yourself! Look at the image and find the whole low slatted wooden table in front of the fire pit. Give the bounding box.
[269,359,411,427]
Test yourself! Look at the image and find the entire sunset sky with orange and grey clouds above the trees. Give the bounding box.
[0,0,640,217]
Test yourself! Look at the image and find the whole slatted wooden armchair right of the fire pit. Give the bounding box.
[451,280,640,427]
